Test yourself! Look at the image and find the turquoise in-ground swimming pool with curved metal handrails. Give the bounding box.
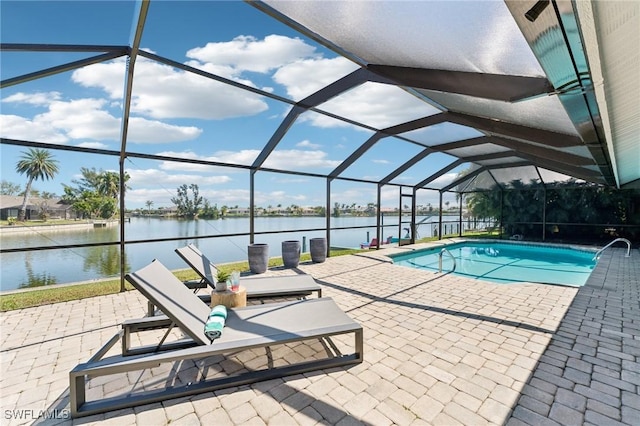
[390,241,596,287]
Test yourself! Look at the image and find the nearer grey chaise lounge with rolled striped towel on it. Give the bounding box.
[69,260,363,417]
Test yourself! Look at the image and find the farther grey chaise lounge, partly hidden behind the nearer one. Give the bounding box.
[164,244,322,316]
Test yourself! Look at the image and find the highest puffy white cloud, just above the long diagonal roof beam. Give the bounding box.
[187,34,315,74]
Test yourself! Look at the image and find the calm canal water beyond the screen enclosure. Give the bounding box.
[0,217,450,291]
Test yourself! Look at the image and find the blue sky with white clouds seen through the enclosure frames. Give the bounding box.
[0,0,468,208]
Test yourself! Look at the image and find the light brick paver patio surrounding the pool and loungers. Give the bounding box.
[0,248,640,426]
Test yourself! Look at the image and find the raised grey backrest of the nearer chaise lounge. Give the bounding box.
[125,259,211,345]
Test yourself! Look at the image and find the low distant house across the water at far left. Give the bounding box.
[0,195,78,220]
